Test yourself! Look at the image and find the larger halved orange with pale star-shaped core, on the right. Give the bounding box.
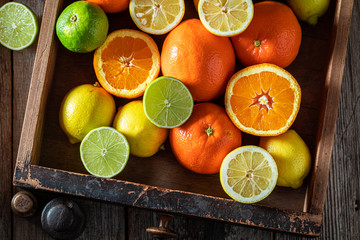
[225,63,301,136]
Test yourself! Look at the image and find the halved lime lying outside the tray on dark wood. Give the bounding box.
[0,2,39,50]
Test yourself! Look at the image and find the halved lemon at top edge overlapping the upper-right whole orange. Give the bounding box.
[198,0,254,37]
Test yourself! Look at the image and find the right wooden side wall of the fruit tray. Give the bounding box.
[306,0,353,216]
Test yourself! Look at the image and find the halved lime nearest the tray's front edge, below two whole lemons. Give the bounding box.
[80,127,130,178]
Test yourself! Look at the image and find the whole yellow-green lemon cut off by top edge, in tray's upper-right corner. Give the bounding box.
[288,0,330,25]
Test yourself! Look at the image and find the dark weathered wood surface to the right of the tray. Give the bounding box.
[322,1,360,239]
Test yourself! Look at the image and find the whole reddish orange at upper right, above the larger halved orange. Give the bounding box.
[231,1,301,68]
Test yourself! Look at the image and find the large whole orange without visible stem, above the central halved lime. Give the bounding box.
[161,19,236,101]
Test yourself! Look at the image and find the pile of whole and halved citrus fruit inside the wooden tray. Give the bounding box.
[14,0,330,203]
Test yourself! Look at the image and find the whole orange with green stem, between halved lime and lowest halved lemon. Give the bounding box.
[169,102,241,174]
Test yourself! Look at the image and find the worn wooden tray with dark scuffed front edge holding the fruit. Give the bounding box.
[13,0,353,236]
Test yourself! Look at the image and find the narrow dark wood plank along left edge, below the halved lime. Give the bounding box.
[0,0,13,239]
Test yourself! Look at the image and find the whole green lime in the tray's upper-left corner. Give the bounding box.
[56,1,109,53]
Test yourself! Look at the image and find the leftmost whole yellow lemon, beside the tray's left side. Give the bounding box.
[59,84,116,143]
